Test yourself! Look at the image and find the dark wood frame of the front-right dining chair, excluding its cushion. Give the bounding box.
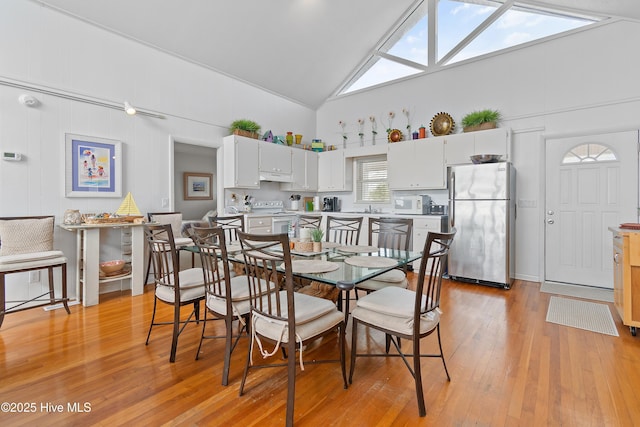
[349,230,455,417]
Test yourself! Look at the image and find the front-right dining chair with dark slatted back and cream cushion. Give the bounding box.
[349,229,455,417]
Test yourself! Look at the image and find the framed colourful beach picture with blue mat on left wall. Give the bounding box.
[65,133,122,197]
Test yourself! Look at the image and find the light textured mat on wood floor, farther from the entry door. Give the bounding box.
[547,297,618,337]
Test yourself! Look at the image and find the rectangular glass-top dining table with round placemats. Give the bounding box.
[183,242,422,321]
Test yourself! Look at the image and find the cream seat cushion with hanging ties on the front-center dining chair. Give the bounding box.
[254,291,344,343]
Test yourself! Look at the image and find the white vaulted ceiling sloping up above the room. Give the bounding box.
[32,0,640,109]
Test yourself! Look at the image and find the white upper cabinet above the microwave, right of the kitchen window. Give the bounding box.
[387,138,446,190]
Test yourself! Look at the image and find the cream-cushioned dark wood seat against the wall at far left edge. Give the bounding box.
[0,215,71,326]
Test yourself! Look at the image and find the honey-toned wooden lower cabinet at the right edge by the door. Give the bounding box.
[610,228,640,336]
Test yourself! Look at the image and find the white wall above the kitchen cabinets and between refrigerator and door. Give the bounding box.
[317,21,640,281]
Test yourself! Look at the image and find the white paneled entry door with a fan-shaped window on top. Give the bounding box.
[545,131,638,288]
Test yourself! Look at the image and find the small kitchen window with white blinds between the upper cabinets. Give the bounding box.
[356,156,390,203]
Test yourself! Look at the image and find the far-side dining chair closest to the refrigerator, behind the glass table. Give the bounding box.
[356,218,413,293]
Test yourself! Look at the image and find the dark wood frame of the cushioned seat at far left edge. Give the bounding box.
[0,215,71,327]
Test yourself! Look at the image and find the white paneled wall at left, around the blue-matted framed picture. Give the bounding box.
[0,0,315,298]
